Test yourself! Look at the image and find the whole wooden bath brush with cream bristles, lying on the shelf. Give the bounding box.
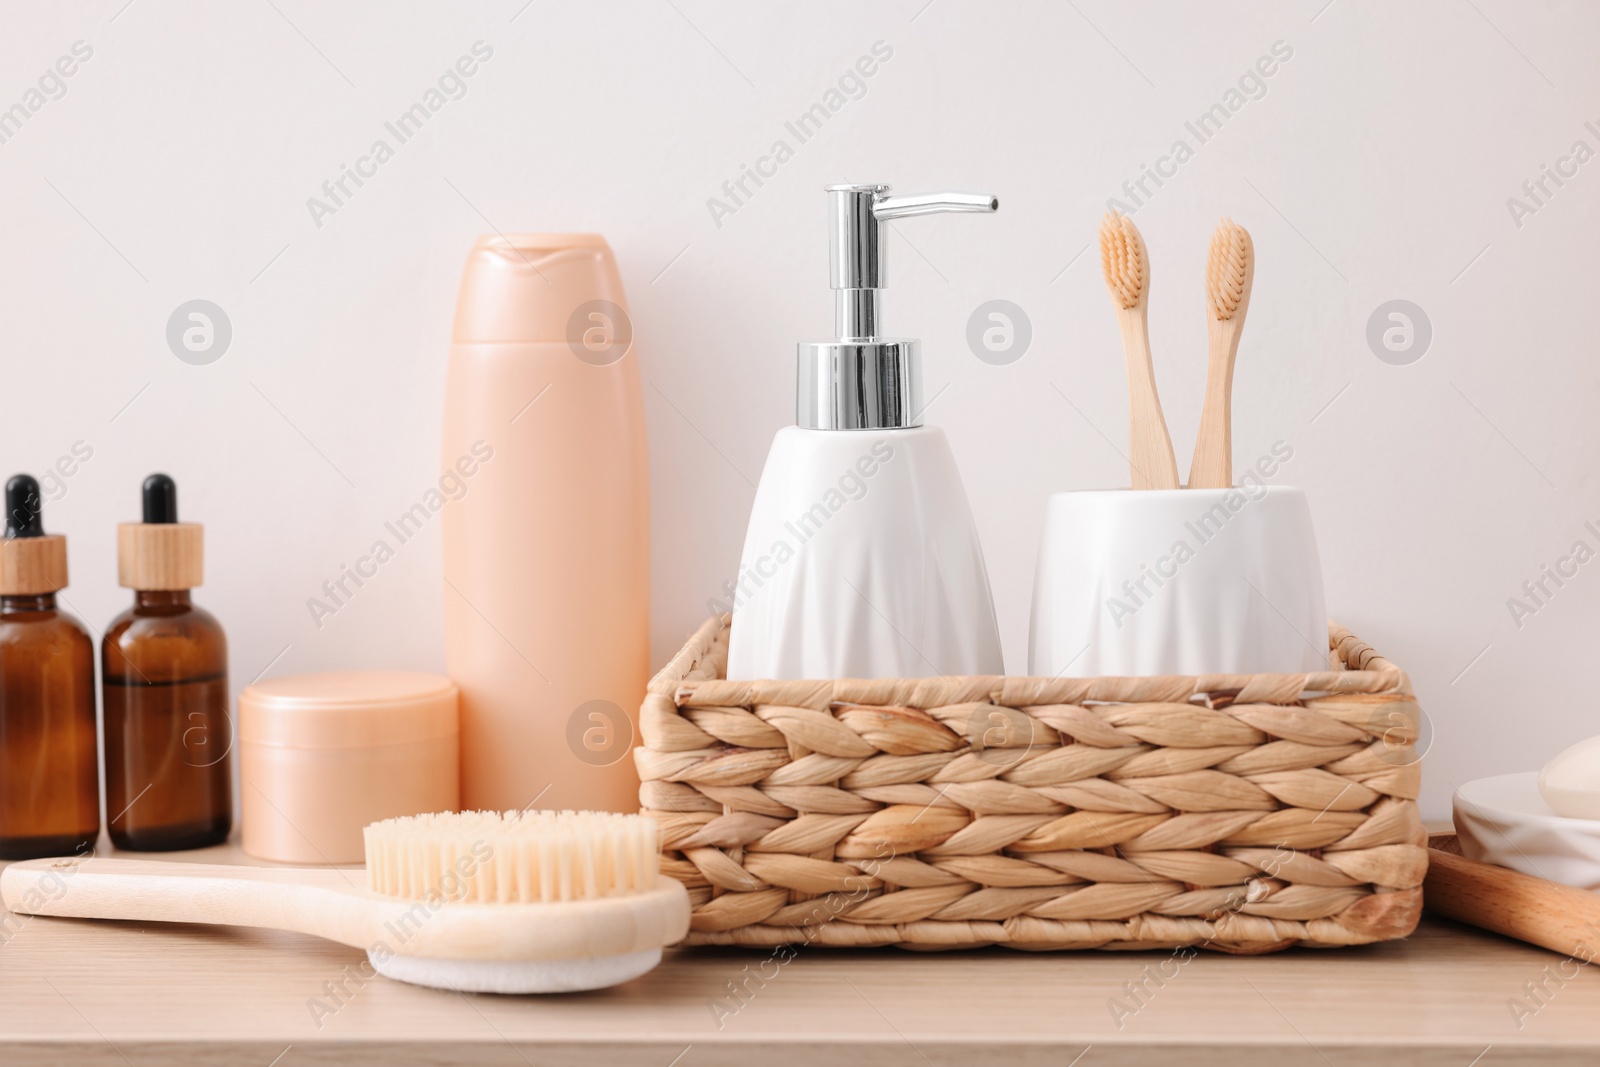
[0,811,690,993]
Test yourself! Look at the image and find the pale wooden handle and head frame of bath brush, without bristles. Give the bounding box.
[0,857,690,960]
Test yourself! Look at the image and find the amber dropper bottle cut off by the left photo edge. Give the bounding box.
[0,474,99,859]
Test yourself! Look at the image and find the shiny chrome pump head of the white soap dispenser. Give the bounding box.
[795,186,1000,430]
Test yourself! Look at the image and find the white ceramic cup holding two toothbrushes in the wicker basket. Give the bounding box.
[1029,482,1330,678]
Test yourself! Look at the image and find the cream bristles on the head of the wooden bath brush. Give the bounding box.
[363,811,661,904]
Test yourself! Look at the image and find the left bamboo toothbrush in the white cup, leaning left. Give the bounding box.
[1101,213,1178,490]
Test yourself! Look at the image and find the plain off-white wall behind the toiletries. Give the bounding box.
[0,0,1600,817]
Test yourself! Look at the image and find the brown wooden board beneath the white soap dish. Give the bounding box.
[1422,833,1600,960]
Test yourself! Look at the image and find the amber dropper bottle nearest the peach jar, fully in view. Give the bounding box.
[101,474,234,851]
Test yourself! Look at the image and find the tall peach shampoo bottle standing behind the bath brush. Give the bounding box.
[442,234,650,811]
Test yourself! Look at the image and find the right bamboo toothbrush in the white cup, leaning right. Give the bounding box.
[1189,218,1256,490]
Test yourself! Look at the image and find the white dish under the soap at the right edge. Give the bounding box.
[1454,771,1600,891]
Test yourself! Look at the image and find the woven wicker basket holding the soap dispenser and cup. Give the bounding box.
[634,616,1427,952]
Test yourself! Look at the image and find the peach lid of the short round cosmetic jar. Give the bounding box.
[238,670,459,749]
